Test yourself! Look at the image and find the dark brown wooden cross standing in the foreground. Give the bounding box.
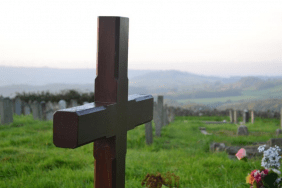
[53,16,154,188]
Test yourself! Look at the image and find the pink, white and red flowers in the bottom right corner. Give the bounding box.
[236,145,282,188]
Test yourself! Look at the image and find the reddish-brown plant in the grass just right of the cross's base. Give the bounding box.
[141,172,180,188]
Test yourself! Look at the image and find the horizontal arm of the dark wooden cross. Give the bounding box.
[53,94,153,148]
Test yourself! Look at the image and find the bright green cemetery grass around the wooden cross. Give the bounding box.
[0,115,280,188]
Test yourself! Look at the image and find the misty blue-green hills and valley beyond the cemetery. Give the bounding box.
[0,66,282,112]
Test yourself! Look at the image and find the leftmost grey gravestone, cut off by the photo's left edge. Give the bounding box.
[0,97,13,124]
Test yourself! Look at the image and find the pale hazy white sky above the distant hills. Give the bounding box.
[0,0,282,76]
